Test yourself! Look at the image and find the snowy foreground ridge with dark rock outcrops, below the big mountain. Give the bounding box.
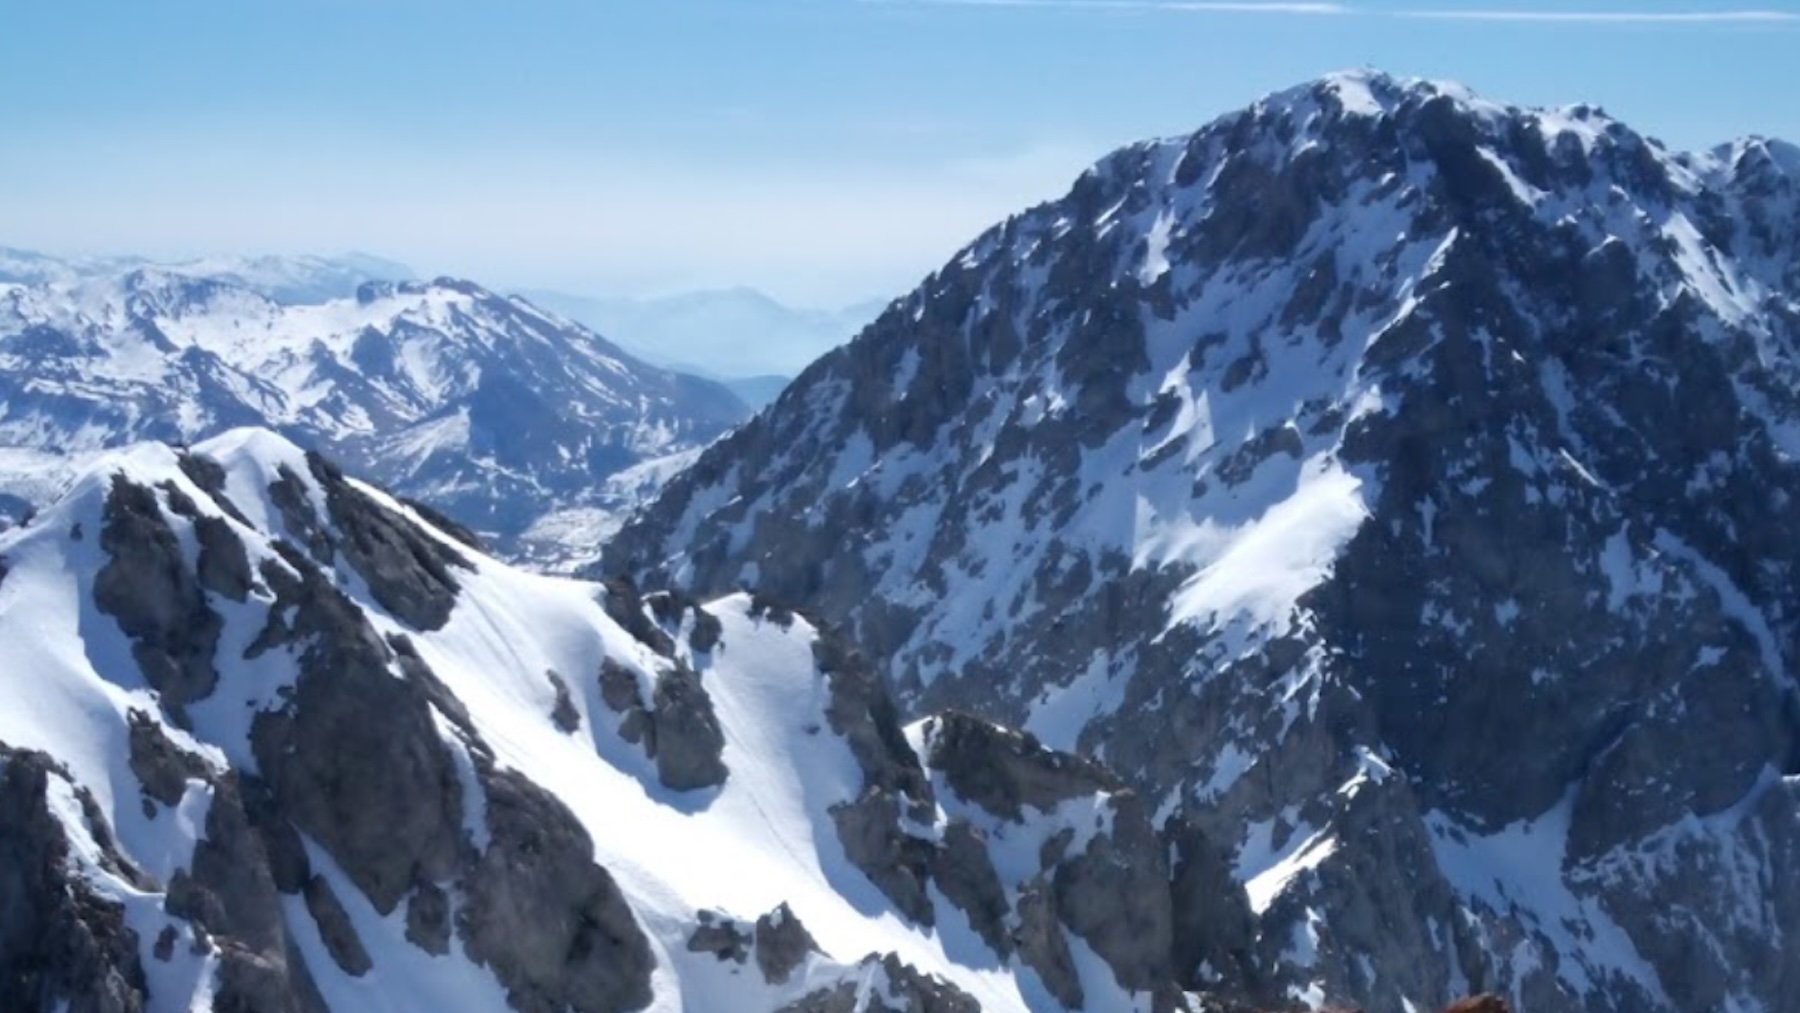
[0,430,1238,1013]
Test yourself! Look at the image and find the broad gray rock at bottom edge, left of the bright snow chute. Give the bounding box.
[455,765,655,1013]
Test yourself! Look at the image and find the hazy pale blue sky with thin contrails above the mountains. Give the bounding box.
[0,0,1800,304]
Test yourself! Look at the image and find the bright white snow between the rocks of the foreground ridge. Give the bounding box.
[0,430,1147,1013]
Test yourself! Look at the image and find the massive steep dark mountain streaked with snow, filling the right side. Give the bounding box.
[607,74,1800,1013]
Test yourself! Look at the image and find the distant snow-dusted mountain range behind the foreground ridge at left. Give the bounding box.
[0,254,747,563]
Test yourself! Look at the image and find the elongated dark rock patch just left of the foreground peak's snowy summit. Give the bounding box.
[94,475,221,725]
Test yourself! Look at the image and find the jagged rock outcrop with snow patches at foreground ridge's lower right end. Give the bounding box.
[823,705,1267,1009]
